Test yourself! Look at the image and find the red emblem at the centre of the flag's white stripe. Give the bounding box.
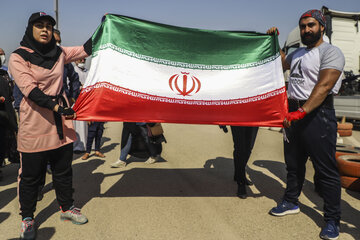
[169,72,201,96]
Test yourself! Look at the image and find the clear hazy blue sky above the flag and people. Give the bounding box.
[0,0,360,62]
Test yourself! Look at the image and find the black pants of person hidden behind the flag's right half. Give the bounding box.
[231,126,259,184]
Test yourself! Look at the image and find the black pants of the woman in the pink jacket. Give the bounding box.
[19,143,74,219]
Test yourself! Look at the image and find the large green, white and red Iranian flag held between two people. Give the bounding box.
[74,14,287,126]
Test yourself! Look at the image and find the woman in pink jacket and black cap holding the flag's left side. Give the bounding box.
[9,12,92,239]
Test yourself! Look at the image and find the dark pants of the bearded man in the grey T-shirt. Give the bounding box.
[284,106,341,222]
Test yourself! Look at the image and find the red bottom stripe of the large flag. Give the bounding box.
[74,84,287,127]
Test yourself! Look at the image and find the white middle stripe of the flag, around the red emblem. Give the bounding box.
[84,49,284,100]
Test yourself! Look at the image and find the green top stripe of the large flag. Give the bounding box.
[92,14,279,68]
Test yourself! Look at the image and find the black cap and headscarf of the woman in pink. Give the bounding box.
[20,12,62,69]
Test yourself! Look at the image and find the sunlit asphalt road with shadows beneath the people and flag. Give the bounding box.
[0,123,360,240]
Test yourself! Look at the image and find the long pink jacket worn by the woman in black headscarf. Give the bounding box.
[9,46,88,152]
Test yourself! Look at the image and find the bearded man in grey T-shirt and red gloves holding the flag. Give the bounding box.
[267,10,345,239]
